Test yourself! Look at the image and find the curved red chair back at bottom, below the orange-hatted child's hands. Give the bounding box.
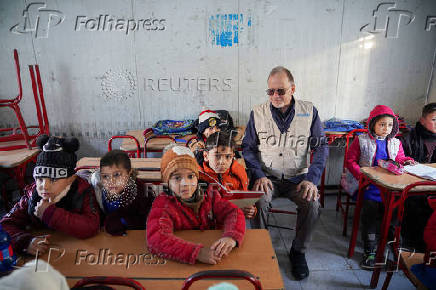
[182,270,262,290]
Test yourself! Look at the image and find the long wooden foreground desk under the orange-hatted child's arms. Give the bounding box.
[35,230,284,289]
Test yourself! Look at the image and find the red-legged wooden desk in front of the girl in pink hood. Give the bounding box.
[348,163,436,288]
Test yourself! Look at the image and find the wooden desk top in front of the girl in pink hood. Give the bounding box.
[360,163,436,192]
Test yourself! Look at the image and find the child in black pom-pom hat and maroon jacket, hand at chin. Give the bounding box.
[0,135,100,255]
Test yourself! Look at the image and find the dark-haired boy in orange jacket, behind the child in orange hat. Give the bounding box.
[200,131,256,218]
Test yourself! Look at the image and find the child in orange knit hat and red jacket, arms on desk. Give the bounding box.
[147,146,245,264]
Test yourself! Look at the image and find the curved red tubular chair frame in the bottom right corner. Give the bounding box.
[382,181,436,289]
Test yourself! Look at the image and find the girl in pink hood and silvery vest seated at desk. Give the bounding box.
[345,105,415,270]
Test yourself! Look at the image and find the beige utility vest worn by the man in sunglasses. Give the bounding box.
[253,99,313,179]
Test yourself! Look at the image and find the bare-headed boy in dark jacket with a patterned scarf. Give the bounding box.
[79,150,154,236]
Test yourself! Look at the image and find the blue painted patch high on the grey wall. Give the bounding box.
[209,13,252,47]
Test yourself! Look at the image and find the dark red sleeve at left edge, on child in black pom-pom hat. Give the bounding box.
[0,196,33,253]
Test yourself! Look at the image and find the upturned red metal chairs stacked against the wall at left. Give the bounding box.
[0,49,50,151]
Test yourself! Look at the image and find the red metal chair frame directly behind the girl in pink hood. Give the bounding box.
[336,129,368,237]
